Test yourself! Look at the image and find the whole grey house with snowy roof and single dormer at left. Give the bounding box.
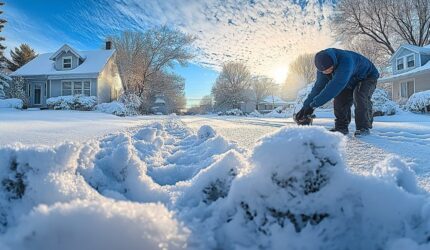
[11,42,122,107]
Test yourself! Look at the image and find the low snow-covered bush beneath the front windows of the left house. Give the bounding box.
[46,95,97,111]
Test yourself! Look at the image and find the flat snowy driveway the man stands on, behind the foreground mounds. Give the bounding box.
[181,112,430,190]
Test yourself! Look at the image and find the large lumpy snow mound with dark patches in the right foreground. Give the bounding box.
[183,128,430,249]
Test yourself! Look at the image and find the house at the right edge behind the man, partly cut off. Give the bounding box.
[378,44,430,104]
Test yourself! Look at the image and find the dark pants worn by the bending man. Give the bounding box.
[333,79,377,130]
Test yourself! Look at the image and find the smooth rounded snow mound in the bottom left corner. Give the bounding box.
[3,200,189,250]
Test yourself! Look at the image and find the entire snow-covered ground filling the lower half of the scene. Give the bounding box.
[0,109,430,250]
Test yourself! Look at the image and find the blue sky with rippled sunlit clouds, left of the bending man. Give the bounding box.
[3,0,333,105]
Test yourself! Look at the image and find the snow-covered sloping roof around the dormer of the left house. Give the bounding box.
[10,50,115,76]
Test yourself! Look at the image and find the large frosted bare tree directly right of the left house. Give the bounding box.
[112,26,195,95]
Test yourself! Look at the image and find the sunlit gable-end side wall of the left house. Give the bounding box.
[97,57,122,103]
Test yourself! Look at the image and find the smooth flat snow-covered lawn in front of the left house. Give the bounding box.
[0,108,163,145]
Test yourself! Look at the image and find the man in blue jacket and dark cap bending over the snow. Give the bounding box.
[294,48,379,136]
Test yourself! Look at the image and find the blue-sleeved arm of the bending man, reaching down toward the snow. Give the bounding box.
[309,59,354,108]
